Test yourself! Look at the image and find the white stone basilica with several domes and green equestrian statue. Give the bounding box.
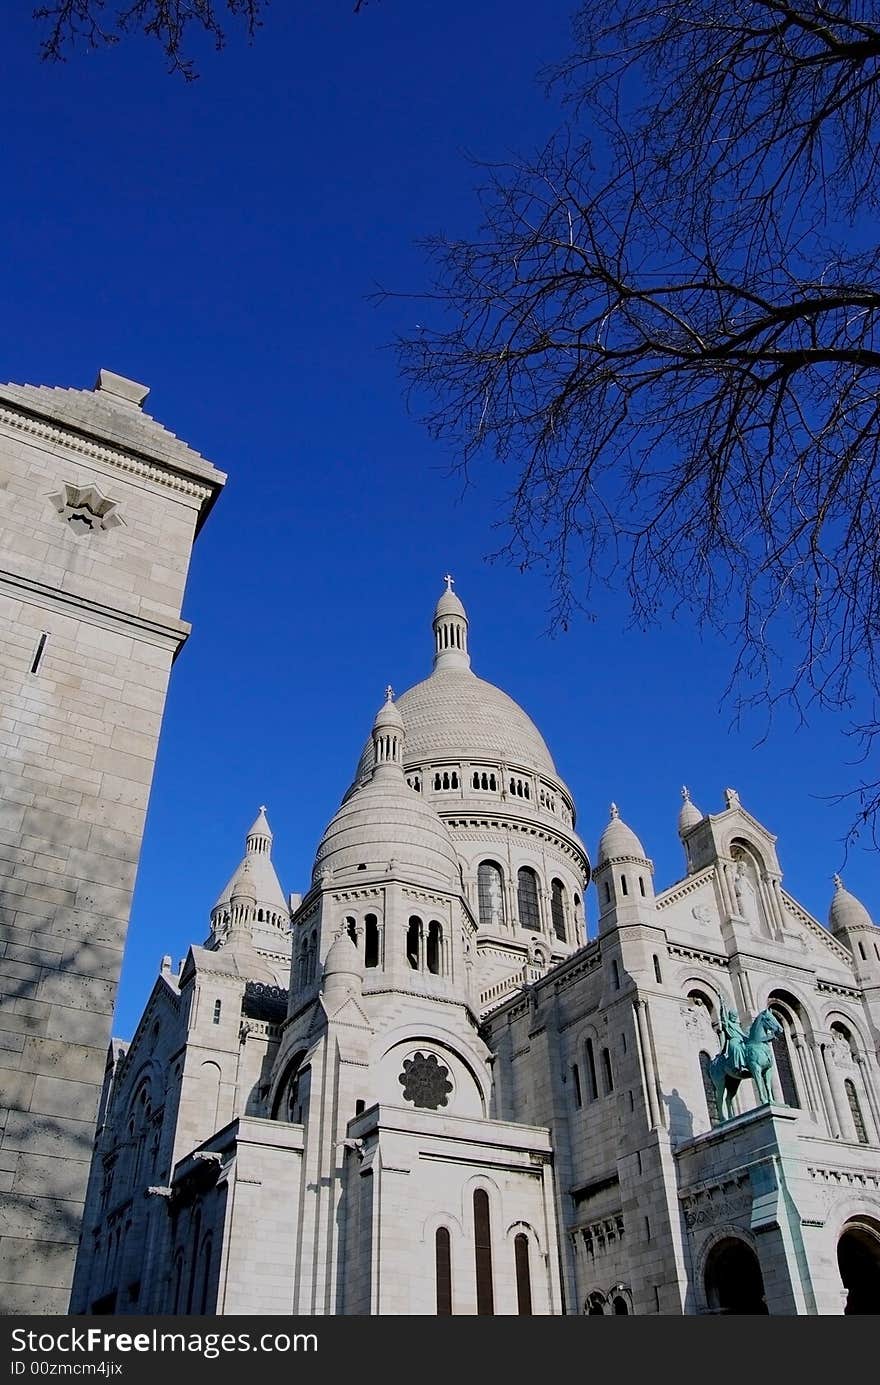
[71,580,880,1316]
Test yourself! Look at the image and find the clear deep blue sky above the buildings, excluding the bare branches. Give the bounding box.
[0,0,880,1036]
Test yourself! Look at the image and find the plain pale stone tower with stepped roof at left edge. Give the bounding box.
[0,370,226,1313]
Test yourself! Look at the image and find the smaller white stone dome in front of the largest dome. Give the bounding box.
[313,769,460,889]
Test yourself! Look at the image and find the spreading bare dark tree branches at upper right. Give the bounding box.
[399,0,880,827]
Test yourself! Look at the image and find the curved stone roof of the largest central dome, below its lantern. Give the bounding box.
[358,667,556,780]
